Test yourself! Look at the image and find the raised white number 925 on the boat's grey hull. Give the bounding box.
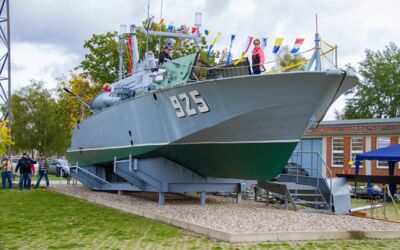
[169,90,210,118]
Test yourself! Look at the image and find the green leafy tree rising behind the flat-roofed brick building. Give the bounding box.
[340,43,400,119]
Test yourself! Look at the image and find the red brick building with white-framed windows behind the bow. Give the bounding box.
[300,118,400,176]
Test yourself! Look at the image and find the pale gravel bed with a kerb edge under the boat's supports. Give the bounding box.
[51,185,400,233]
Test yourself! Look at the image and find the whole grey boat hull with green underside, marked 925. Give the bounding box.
[67,71,358,180]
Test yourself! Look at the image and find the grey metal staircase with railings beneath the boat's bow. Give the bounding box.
[257,152,351,214]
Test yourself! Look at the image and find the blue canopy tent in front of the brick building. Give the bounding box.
[355,144,400,194]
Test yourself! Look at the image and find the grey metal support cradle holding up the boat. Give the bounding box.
[71,155,255,206]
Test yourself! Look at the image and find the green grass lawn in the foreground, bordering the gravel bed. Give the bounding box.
[0,189,400,250]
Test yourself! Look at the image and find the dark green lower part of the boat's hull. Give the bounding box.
[67,142,297,180]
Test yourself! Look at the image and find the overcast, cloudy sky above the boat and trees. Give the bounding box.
[6,0,400,119]
